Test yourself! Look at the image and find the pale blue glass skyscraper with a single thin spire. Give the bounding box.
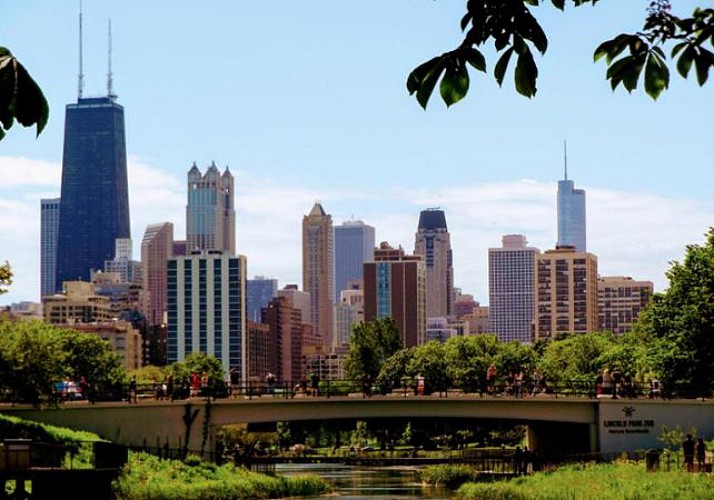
[556,146,587,252]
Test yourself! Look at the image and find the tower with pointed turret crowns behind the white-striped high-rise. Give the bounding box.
[186,163,236,255]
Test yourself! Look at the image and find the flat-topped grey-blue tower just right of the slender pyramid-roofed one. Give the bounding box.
[335,220,375,303]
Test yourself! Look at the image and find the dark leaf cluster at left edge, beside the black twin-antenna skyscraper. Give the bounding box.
[0,47,49,140]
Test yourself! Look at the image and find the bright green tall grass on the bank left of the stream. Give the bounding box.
[114,453,330,500]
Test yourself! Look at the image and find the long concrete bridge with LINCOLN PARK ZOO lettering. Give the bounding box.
[5,395,714,453]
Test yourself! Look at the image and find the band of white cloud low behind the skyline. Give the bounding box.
[0,157,714,303]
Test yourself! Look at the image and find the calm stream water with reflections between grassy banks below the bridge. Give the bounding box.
[275,464,450,500]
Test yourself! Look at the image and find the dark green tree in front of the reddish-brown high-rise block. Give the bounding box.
[345,318,403,382]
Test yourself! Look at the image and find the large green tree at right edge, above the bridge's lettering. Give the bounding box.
[636,228,714,394]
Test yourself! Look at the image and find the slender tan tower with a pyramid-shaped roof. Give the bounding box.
[302,203,335,349]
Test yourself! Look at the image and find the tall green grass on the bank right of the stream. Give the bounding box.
[457,462,714,500]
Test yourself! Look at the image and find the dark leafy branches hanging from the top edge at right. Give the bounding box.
[407,0,714,108]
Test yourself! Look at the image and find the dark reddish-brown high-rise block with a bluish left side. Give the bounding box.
[364,242,427,347]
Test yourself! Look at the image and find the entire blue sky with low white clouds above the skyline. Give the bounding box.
[0,0,714,303]
